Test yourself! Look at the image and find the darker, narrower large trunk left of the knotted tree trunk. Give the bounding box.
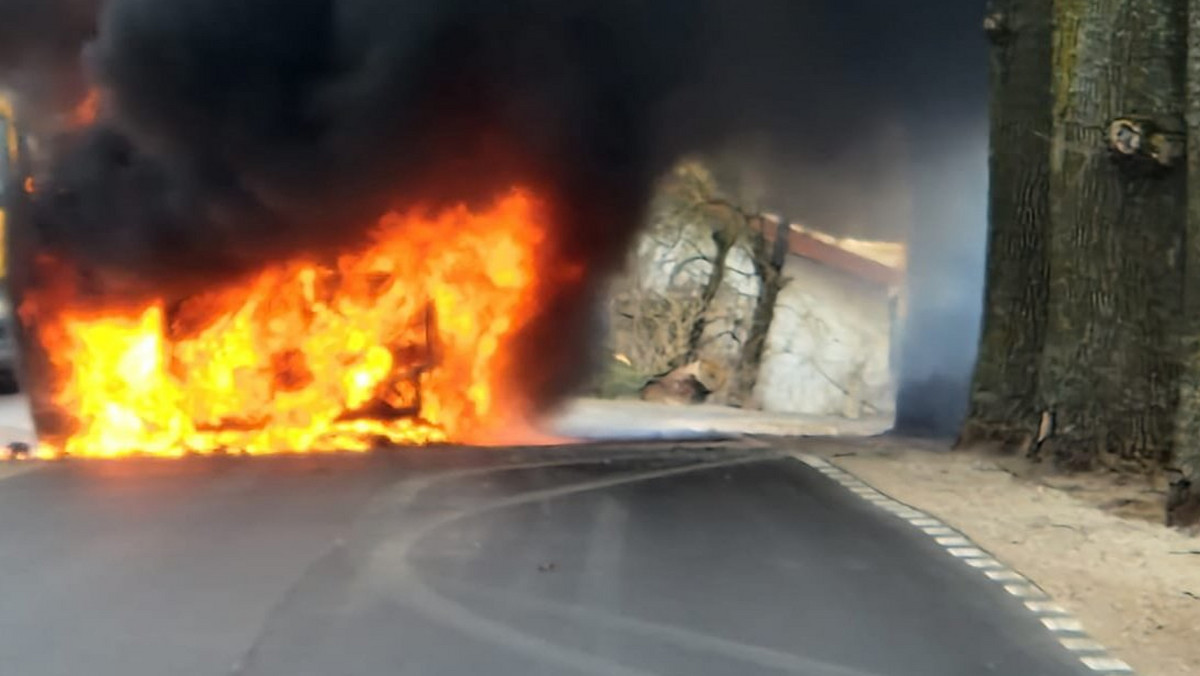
[960,0,1054,445]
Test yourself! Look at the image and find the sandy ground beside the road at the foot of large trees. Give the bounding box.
[806,438,1200,676]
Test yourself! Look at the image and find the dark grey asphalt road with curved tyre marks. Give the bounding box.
[0,443,1082,676]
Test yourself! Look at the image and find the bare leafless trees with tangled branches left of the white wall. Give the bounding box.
[604,160,788,405]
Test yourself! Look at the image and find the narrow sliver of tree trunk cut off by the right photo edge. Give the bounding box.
[1166,0,1200,525]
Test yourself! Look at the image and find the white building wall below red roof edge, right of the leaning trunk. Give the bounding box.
[755,256,894,418]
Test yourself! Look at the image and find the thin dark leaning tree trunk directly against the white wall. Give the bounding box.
[732,217,792,406]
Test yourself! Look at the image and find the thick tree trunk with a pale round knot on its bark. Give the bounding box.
[1039,0,1186,468]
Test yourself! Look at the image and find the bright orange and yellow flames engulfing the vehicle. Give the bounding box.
[22,187,572,456]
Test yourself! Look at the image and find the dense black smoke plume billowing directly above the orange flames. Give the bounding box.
[0,0,820,415]
